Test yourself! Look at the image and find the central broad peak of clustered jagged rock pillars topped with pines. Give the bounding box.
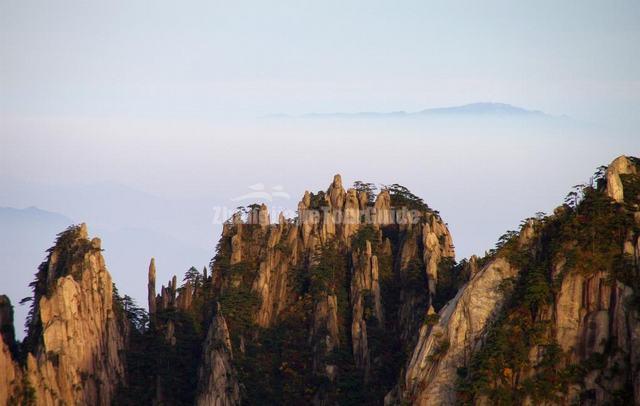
[202,175,454,404]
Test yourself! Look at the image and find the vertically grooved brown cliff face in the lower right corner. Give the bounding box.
[553,268,640,405]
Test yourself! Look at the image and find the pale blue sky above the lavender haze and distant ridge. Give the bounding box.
[0,0,640,125]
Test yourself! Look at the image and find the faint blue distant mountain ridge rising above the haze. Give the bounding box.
[276,102,555,118]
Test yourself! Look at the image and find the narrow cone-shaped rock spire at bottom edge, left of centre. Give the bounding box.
[196,306,240,406]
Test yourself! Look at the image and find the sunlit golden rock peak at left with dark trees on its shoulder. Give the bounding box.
[25,224,126,405]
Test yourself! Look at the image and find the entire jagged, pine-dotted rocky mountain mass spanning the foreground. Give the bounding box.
[0,157,640,405]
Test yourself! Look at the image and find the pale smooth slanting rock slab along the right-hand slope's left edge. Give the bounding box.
[385,258,518,405]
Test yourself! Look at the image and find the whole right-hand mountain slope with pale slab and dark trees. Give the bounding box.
[386,157,640,405]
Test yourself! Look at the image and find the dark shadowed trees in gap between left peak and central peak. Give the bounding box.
[114,267,212,405]
